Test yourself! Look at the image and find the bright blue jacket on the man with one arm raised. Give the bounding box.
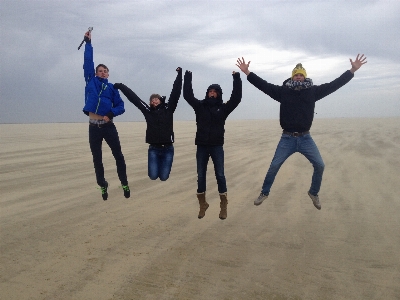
[82,42,125,119]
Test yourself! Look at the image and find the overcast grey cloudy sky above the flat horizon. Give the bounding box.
[0,0,400,123]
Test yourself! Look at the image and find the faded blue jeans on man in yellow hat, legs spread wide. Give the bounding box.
[261,134,325,195]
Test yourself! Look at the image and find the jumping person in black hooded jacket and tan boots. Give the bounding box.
[183,71,242,220]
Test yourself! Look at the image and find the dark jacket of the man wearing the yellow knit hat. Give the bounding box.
[247,71,354,132]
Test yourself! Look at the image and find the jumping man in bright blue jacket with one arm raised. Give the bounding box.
[83,31,130,200]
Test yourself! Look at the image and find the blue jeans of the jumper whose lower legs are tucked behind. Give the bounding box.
[148,145,174,181]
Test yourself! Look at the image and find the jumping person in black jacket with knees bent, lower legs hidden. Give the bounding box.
[114,68,182,181]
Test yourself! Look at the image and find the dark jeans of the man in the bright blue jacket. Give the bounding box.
[89,123,128,186]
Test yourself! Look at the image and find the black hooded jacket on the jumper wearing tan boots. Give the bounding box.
[183,71,242,146]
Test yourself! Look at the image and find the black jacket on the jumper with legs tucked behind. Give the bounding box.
[114,69,182,144]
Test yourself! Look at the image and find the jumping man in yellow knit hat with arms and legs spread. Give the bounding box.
[237,54,367,209]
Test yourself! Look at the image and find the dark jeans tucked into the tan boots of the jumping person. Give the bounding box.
[196,145,227,194]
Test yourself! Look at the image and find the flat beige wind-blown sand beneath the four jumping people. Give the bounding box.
[0,118,400,300]
